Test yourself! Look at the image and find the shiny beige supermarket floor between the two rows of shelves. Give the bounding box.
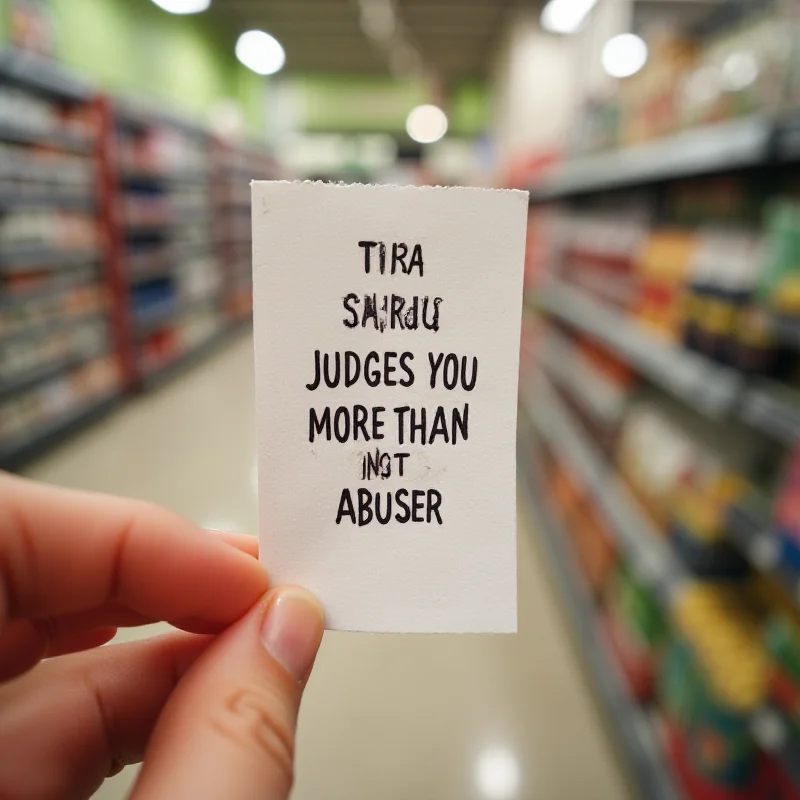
[23,337,627,800]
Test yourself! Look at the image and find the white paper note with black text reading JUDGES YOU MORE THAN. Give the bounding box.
[253,182,528,633]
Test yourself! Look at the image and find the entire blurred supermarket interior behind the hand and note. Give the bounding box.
[0,0,800,800]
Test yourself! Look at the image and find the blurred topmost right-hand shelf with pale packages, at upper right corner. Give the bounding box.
[532,0,800,202]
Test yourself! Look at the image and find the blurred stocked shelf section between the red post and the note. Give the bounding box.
[105,103,226,388]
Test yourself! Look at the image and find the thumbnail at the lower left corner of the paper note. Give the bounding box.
[261,586,325,681]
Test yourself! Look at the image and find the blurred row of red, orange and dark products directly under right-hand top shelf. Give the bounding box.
[528,184,800,447]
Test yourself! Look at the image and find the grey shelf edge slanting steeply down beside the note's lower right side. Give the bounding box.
[522,374,688,605]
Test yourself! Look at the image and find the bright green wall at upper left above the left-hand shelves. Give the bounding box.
[5,0,266,135]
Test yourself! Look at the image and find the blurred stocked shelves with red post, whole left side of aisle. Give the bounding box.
[0,51,275,467]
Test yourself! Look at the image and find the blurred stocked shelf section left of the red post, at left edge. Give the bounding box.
[0,51,122,469]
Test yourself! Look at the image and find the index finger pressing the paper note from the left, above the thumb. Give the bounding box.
[0,475,267,628]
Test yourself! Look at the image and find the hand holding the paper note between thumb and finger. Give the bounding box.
[0,475,324,800]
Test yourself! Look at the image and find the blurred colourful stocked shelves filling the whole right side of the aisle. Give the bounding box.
[520,2,800,800]
